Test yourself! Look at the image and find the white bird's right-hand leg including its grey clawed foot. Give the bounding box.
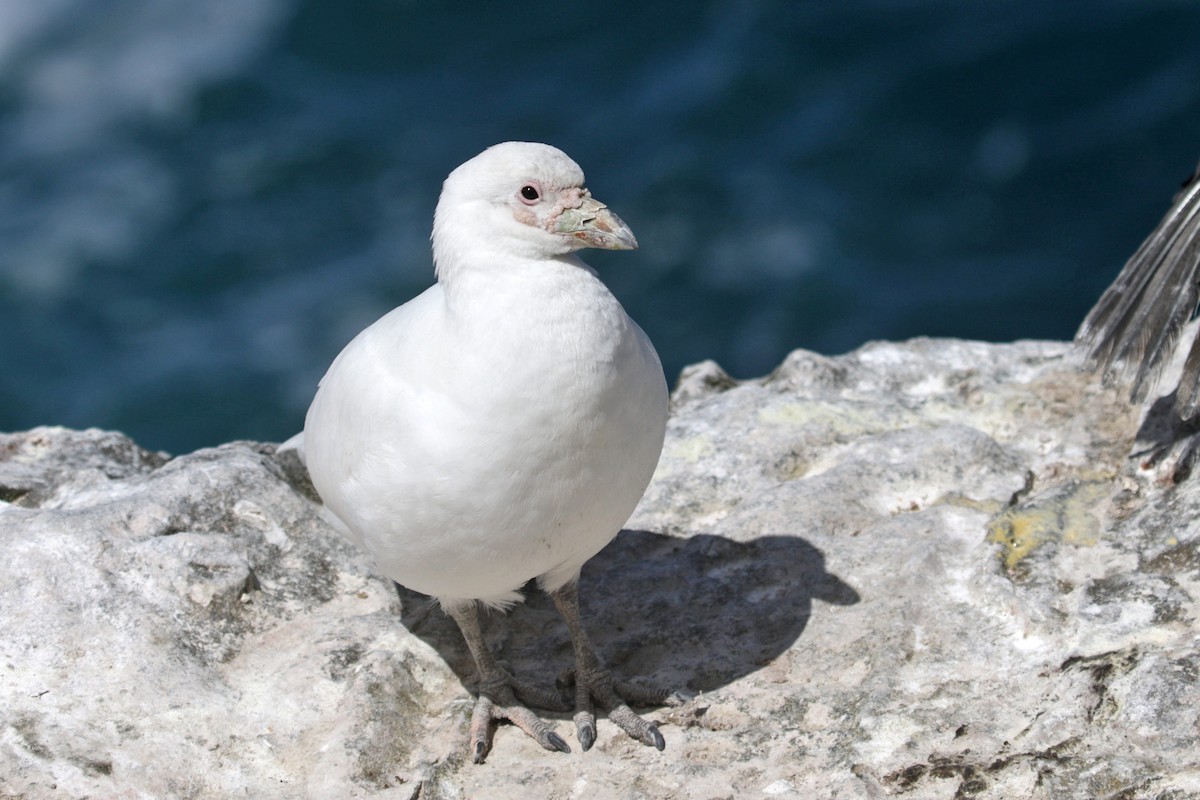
[551,581,689,750]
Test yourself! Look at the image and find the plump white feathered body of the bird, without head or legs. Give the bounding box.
[305,258,667,602]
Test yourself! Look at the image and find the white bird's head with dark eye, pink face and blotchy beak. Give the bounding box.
[433,142,637,275]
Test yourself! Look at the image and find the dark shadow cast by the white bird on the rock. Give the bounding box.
[397,530,859,692]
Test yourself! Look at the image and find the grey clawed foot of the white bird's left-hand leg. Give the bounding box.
[470,672,571,764]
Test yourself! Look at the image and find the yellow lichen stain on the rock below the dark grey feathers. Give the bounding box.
[988,481,1112,570]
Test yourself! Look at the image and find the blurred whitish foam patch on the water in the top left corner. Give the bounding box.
[0,0,284,300]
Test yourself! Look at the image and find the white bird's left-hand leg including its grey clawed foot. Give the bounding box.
[446,602,571,764]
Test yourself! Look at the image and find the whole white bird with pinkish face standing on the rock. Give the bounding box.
[304,142,685,763]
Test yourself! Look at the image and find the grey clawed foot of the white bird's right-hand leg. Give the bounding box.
[563,667,691,751]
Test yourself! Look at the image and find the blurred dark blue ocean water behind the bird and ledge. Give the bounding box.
[0,0,1200,452]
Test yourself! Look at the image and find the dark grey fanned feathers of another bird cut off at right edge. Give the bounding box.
[1075,168,1200,417]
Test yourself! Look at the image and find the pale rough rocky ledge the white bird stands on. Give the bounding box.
[0,339,1200,800]
